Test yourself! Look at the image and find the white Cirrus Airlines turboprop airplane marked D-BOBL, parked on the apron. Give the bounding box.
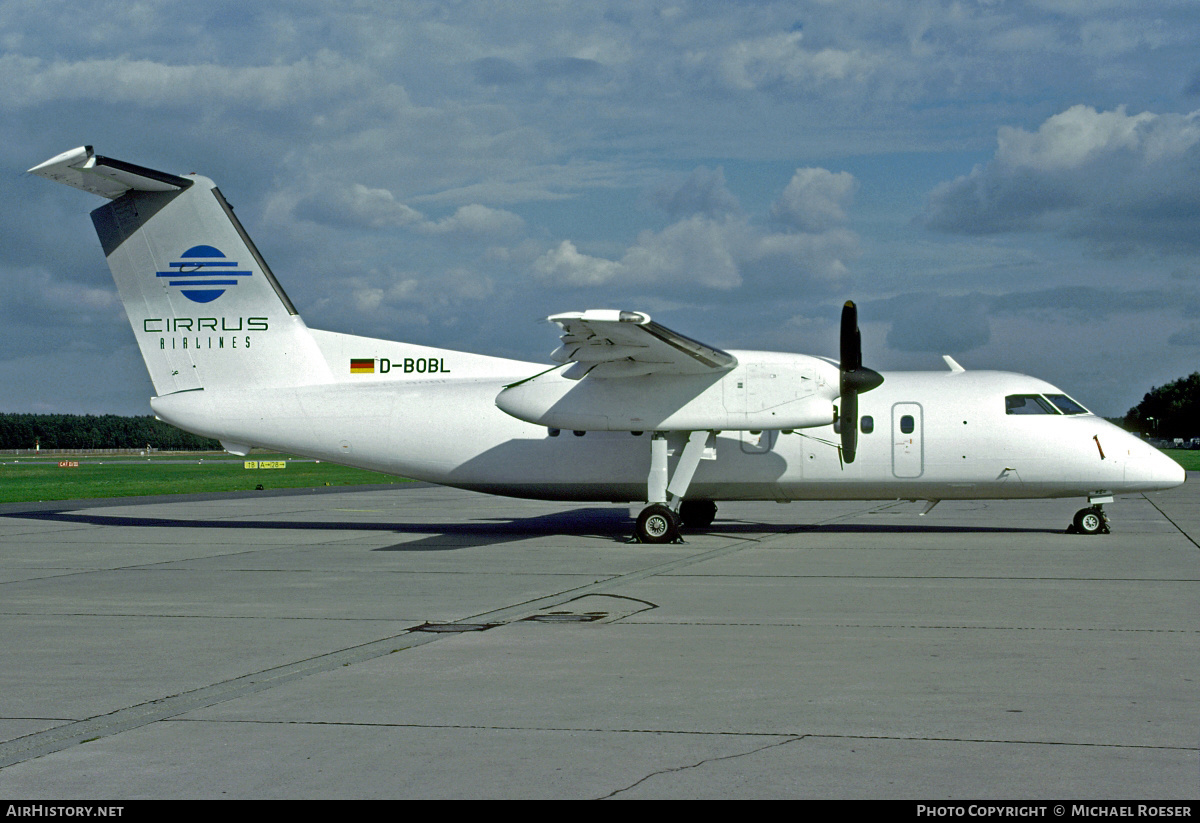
[30,146,1184,542]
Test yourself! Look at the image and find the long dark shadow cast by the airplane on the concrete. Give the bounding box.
[0,507,1062,552]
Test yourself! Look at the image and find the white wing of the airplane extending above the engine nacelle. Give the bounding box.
[548,308,738,380]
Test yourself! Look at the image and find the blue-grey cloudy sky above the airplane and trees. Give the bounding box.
[0,0,1200,415]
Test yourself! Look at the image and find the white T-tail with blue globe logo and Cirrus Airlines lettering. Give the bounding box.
[30,146,331,396]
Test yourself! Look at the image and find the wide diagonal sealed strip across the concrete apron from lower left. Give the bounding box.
[0,510,883,769]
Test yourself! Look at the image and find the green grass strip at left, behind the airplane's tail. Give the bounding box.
[0,452,408,503]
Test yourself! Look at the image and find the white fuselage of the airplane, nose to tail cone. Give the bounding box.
[152,352,1183,501]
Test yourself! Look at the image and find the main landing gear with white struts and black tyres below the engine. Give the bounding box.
[637,432,716,543]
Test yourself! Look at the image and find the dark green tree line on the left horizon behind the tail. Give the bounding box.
[0,413,221,451]
